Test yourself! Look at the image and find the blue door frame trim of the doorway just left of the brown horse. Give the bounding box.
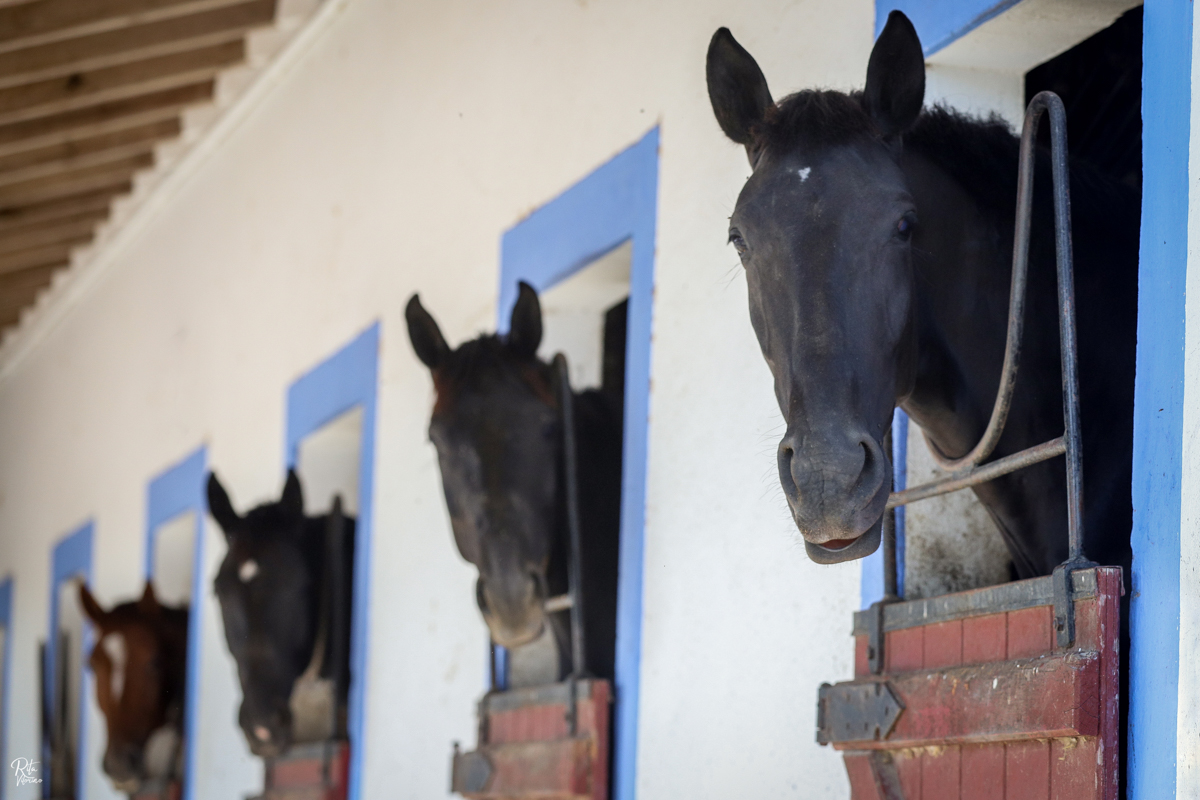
[42,519,95,800]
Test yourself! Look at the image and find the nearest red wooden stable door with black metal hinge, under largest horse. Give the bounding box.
[817,567,1122,800]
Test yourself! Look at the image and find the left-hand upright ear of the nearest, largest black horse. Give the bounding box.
[704,28,775,162]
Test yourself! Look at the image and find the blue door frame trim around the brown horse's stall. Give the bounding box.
[145,447,208,800]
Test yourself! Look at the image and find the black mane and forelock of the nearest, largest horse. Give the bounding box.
[755,90,1135,235]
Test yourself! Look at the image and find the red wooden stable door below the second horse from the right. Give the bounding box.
[450,680,611,800]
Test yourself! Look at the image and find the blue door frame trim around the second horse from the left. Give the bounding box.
[283,323,379,800]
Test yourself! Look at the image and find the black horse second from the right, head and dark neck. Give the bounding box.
[404,282,624,679]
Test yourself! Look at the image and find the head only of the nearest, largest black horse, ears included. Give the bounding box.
[707,12,925,564]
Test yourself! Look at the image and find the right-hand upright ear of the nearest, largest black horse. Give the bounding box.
[863,11,925,138]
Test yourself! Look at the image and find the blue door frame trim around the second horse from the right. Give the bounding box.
[497,127,659,800]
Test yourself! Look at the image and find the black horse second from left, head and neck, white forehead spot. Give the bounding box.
[208,470,354,758]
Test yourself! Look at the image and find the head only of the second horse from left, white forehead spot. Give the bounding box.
[208,470,320,757]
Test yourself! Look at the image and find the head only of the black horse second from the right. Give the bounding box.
[406,283,562,648]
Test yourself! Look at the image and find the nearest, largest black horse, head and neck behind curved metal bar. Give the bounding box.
[707,12,1140,577]
